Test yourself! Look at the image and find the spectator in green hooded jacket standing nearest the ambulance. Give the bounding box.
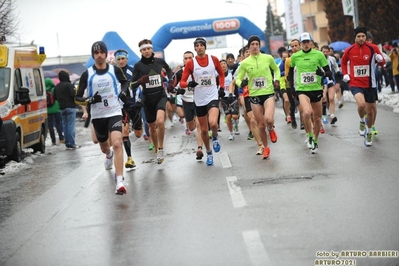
[45,78,65,146]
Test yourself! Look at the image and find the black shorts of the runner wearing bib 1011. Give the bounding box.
[142,91,168,123]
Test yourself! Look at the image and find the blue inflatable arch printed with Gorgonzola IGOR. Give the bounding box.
[151,17,268,57]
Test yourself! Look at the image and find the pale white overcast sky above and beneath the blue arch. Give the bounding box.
[15,0,284,61]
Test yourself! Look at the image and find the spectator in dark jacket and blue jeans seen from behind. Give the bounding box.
[54,71,80,150]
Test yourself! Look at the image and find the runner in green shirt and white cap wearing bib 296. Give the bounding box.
[290,32,332,154]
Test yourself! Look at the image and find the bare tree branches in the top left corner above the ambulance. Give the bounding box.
[0,0,18,39]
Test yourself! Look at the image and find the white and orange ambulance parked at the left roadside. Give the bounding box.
[0,44,47,162]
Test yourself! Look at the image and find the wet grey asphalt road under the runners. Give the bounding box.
[0,103,399,266]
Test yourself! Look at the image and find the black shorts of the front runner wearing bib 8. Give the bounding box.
[91,115,122,143]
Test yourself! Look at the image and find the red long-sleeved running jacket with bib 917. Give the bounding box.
[341,42,385,88]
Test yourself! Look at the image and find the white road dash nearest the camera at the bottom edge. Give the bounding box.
[242,230,272,266]
